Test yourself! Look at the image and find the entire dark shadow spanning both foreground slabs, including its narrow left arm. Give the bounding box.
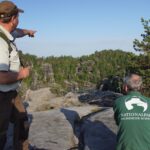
[61,109,116,150]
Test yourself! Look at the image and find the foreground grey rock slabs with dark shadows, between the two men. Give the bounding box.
[5,106,117,150]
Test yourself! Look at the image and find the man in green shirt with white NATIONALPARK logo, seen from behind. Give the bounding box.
[114,74,150,150]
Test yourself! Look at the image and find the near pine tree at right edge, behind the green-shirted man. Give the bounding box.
[127,18,150,96]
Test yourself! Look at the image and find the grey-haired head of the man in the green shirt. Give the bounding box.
[124,74,142,91]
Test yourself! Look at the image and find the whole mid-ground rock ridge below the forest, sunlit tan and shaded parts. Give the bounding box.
[25,88,122,112]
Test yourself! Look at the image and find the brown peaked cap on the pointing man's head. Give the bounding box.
[0,1,24,18]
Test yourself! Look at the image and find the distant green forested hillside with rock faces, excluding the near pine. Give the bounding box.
[22,50,134,94]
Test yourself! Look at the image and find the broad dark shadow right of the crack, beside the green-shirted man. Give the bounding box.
[80,119,116,150]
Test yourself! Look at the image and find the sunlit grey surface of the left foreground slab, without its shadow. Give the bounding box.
[29,110,76,150]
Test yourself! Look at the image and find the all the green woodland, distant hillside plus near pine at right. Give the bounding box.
[20,18,150,96]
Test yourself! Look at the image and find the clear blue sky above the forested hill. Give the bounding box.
[12,0,150,57]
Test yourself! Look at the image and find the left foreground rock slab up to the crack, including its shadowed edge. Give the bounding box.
[29,106,101,150]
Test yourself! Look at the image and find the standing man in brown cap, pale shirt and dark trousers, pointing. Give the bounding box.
[0,1,34,150]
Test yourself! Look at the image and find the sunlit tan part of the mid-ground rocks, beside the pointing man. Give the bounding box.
[24,88,85,112]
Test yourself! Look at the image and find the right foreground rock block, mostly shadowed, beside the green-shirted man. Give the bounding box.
[79,108,117,150]
